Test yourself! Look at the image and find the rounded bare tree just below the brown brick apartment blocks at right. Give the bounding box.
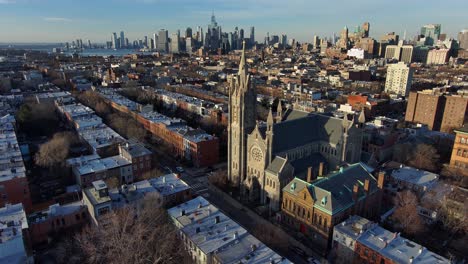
[408,144,440,171]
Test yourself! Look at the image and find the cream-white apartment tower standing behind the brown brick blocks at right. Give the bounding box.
[385,62,414,96]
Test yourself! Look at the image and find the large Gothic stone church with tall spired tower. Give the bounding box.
[228,43,365,211]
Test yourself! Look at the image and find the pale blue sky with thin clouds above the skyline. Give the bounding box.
[0,0,468,43]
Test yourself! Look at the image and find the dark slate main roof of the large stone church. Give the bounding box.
[273,114,352,153]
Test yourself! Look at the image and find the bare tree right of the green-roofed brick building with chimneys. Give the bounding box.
[392,190,424,235]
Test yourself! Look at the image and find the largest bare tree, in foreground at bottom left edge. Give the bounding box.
[54,196,190,264]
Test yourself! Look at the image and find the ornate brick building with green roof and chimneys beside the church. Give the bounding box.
[281,163,384,250]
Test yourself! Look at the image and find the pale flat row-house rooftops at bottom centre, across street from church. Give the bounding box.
[168,196,291,263]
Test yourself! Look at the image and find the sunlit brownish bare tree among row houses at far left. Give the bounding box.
[34,132,78,167]
